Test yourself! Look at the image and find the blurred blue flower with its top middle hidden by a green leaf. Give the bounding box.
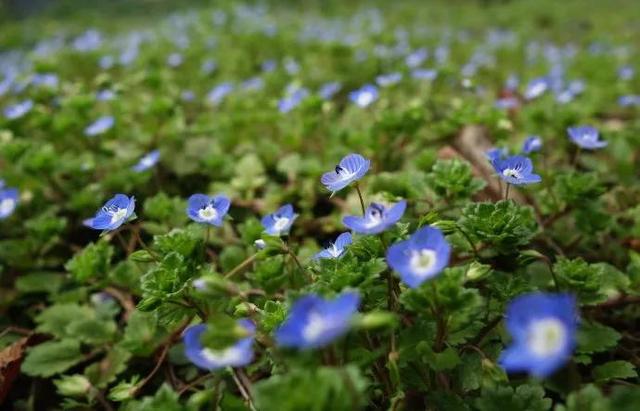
[183,319,256,371]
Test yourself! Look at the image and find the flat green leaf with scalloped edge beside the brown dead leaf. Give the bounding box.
[22,339,84,377]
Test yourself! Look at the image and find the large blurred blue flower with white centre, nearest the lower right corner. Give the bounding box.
[499,292,578,378]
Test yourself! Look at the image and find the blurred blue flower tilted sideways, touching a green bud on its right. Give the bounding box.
[275,292,360,348]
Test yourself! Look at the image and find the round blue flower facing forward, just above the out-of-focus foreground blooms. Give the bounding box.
[387,227,451,288]
